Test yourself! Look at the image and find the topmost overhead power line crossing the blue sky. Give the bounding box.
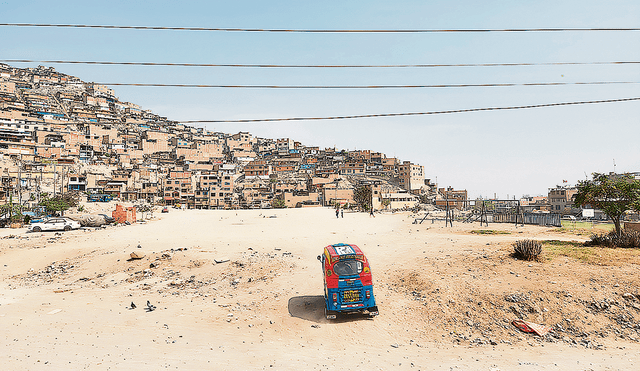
[0,23,640,33]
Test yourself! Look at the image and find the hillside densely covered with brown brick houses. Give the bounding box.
[0,64,450,210]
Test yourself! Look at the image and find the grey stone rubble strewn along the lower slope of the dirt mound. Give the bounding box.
[388,260,640,349]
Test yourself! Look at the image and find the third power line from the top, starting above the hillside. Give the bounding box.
[97,81,640,89]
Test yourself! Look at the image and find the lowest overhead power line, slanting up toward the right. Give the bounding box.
[179,97,640,124]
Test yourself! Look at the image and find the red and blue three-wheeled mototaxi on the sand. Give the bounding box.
[318,243,378,319]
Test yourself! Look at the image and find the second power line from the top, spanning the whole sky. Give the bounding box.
[0,59,640,68]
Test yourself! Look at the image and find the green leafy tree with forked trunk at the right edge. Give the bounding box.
[574,173,640,235]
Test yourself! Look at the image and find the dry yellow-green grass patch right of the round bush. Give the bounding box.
[542,240,640,266]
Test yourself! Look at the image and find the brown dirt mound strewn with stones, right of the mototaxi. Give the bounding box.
[378,241,640,349]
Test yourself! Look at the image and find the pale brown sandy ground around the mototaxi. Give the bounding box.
[0,208,640,370]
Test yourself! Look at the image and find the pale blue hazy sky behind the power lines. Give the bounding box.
[0,0,640,198]
